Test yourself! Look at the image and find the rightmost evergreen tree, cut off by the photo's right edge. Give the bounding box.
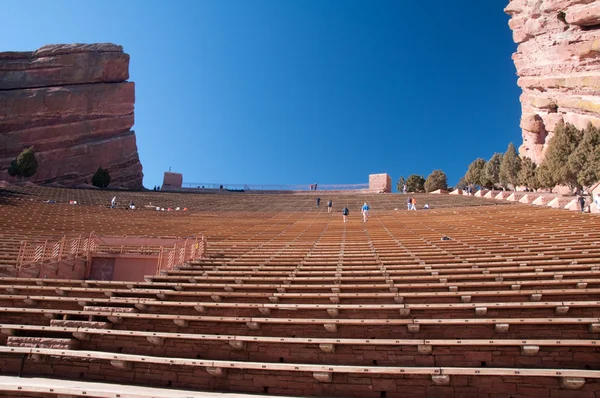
[568,123,600,187]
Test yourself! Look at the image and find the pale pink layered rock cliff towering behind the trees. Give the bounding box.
[505,0,600,163]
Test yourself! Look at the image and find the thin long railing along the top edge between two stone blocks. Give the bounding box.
[178,182,369,191]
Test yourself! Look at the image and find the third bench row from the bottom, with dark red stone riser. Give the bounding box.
[0,321,600,369]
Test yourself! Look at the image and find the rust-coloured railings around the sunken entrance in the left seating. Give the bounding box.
[17,233,206,275]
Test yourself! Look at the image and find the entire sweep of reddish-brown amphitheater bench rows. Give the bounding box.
[0,187,600,398]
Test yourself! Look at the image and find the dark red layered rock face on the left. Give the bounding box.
[0,44,143,189]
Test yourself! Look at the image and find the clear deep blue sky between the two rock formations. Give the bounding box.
[0,0,521,187]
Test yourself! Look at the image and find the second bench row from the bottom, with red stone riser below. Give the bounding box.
[0,347,600,397]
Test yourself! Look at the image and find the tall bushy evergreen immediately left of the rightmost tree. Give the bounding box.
[539,123,583,189]
